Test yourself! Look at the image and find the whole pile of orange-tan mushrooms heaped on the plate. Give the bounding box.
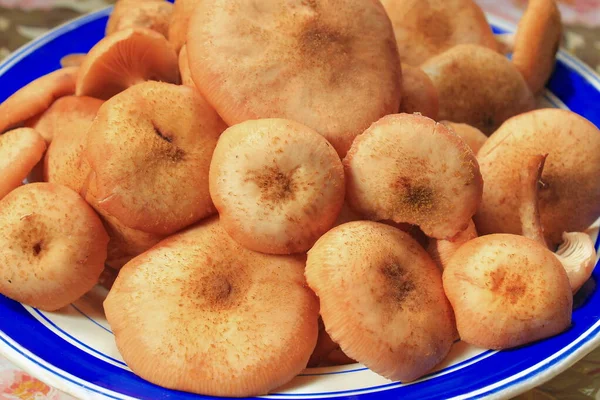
[0,0,600,396]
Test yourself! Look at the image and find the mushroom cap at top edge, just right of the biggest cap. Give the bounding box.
[381,0,496,66]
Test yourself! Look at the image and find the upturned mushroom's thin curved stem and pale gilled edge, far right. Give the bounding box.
[519,154,596,293]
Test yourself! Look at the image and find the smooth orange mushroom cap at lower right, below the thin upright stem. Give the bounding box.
[443,234,573,349]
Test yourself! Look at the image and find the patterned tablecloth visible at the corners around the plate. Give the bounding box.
[0,0,600,400]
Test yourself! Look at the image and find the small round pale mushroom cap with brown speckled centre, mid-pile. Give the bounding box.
[210,118,345,254]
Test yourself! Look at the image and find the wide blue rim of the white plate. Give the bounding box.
[0,7,600,400]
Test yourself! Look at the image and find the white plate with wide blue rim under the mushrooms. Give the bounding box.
[0,8,600,400]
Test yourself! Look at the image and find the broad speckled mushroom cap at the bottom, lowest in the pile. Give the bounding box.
[104,218,319,396]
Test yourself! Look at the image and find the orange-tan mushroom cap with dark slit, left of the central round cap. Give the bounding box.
[85,82,225,235]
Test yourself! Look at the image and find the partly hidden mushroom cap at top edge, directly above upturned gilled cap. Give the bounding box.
[106,0,173,38]
